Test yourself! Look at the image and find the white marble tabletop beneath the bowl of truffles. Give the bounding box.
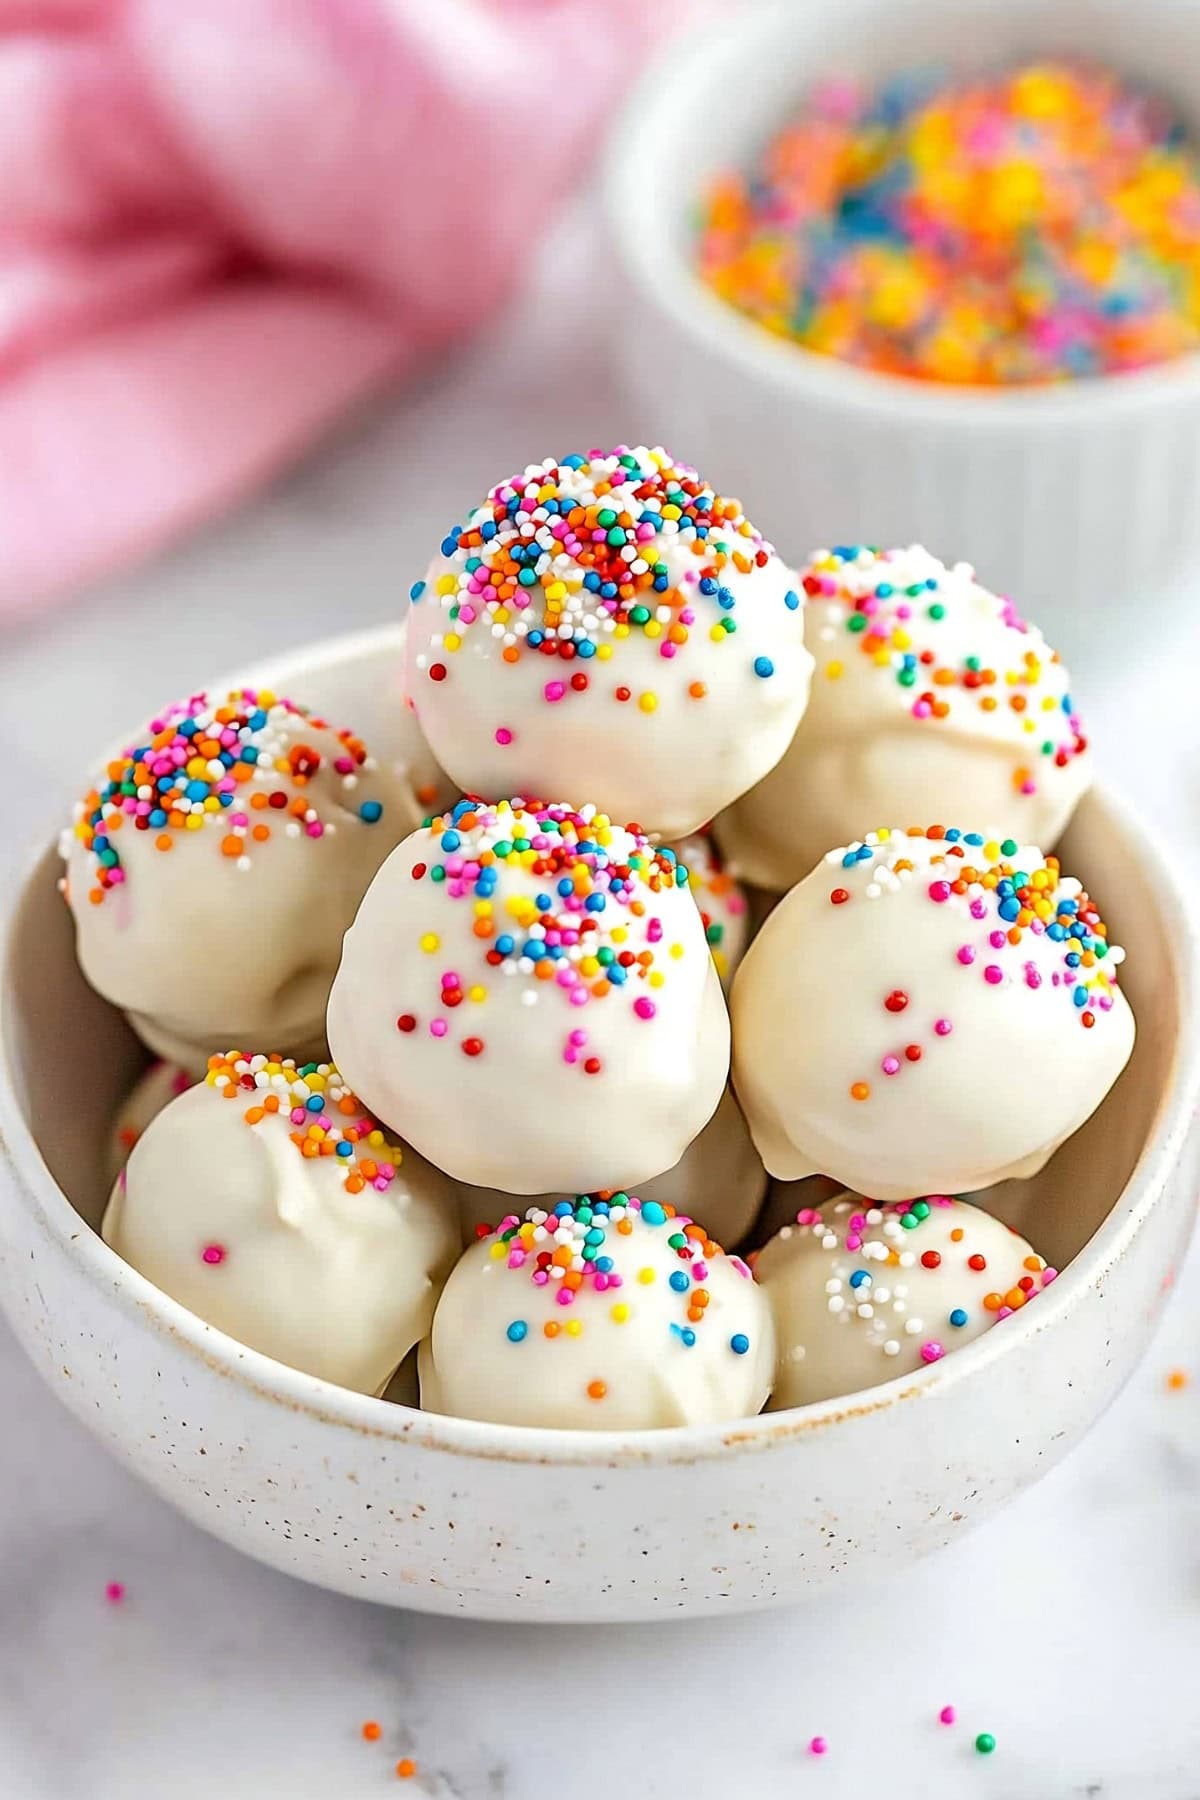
[0,204,1200,1800]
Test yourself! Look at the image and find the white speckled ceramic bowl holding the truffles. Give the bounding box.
[0,632,1200,1620]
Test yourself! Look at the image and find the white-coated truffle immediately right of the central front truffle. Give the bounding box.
[732,826,1133,1201]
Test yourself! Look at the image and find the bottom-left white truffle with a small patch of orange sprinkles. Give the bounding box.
[103,1051,459,1393]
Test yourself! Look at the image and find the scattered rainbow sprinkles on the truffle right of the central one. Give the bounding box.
[826,824,1124,1100]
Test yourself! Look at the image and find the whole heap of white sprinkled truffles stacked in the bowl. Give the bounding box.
[65,448,1133,1429]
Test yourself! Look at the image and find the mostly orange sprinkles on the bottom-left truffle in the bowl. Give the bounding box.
[201,1049,405,1209]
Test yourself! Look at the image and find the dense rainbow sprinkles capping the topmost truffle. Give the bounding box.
[410,446,801,716]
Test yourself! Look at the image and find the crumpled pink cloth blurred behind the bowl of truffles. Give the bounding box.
[0,0,664,614]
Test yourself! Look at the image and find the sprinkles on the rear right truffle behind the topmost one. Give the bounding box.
[802,544,1087,796]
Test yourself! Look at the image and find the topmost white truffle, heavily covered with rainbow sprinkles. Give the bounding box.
[408,448,811,837]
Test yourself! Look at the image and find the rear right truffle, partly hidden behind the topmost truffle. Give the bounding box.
[718,544,1092,889]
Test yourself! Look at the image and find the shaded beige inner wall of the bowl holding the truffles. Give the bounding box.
[0,632,1187,1303]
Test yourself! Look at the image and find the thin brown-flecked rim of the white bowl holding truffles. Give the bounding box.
[0,623,1200,1469]
